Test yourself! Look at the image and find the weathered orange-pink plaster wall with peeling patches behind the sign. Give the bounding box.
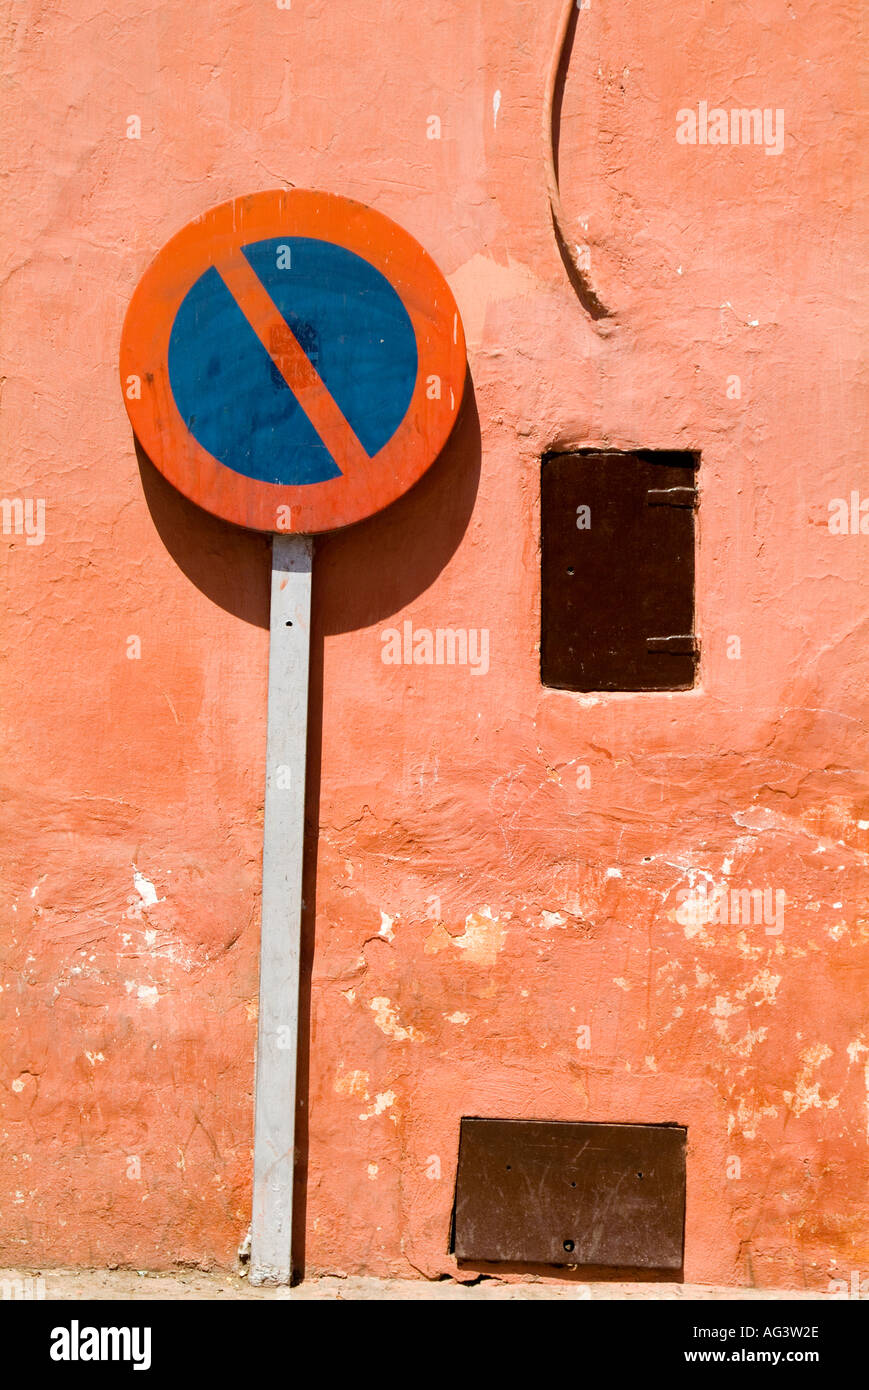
[0,0,869,1287]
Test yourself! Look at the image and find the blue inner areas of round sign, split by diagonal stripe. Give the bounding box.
[168,236,417,485]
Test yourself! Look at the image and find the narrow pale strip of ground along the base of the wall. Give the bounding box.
[0,1269,829,1302]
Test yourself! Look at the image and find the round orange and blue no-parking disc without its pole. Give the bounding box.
[121,189,466,534]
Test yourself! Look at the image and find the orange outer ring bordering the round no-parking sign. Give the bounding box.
[120,189,467,534]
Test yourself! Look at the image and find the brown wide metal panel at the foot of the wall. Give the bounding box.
[455,1119,687,1270]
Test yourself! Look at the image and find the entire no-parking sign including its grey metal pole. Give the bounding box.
[121,190,466,1283]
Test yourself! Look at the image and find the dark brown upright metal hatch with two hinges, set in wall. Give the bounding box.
[541,450,697,691]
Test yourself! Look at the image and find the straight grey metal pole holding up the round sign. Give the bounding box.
[250,535,313,1284]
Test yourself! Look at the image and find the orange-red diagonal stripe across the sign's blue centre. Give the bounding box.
[216,250,368,474]
